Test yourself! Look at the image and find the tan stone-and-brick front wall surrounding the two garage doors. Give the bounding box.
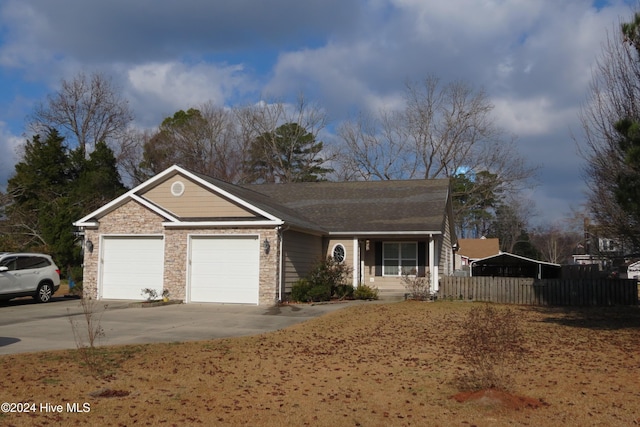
[83,200,280,305]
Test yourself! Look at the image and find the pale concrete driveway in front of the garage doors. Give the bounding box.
[0,297,365,354]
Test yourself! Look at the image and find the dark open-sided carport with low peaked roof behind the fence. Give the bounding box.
[471,252,562,279]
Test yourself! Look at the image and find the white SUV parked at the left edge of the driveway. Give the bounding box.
[0,252,60,302]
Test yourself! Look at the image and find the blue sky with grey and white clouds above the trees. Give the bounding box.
[0,0,635,227]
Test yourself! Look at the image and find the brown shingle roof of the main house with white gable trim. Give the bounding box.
[74,165,450,235]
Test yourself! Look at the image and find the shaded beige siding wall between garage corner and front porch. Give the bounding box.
[282,230,322,293]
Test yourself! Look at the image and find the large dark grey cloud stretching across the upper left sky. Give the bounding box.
[0,0,359,63]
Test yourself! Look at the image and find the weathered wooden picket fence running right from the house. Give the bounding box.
[438,276,638,306]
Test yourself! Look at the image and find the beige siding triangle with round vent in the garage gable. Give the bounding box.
[142,175,256,218]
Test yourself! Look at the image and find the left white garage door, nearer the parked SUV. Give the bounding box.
[102,236,164,300]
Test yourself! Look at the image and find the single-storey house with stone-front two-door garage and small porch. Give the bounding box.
[74,166,456,305]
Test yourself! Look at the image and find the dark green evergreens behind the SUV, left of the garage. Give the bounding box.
[0,129,125,267]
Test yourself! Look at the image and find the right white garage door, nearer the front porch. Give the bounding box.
[189,236,260,304]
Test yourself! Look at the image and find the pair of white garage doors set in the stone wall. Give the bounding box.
[101,236,260,304]
